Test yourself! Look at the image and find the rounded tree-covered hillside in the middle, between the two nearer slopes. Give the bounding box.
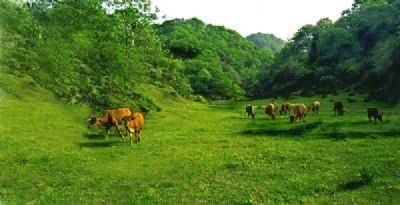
[156,18,272,99]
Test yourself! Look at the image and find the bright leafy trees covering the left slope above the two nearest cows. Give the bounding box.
[0,0,191,111]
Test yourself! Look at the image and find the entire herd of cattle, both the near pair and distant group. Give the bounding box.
[88,101,382,145]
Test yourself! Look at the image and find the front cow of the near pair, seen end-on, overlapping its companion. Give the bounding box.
[124,112,144,145]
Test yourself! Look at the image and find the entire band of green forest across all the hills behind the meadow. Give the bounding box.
[0,0,400,111]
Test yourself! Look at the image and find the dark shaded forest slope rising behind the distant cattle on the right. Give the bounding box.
[260,0,400,103]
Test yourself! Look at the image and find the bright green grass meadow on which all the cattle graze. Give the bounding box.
[0,74,400,205]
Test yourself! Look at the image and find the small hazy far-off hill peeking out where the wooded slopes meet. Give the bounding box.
[246,33,285,53]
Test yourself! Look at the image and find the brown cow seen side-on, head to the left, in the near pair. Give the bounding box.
[88,108,132,140]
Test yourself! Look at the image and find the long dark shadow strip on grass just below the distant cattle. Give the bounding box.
[241,121,322,136]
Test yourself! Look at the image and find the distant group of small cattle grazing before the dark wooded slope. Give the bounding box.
[246,101,382,123]
